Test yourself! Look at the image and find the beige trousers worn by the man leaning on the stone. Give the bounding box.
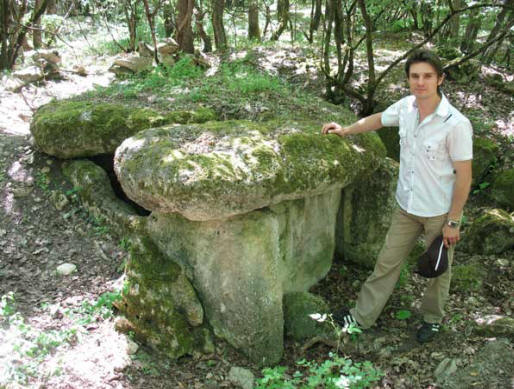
[350,208,455,328]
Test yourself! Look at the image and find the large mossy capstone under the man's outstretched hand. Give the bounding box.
[115,121,385,220]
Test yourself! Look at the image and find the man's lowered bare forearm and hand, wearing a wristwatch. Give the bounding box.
[443,160,471,247]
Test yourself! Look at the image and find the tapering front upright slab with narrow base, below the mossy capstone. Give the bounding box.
[148,210,284,365]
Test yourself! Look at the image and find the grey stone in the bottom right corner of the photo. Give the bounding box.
[437,339,514,389]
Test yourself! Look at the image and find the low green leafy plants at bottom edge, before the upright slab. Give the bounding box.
[256,353,383,389]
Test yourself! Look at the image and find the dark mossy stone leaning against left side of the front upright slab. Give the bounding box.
[120,235,208,358]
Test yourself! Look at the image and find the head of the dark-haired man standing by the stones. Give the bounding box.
[405,50,444,98]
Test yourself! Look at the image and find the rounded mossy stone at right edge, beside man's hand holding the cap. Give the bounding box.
[464,209,514,254]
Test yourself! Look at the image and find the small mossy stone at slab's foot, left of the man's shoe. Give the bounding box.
[284,292,333,340]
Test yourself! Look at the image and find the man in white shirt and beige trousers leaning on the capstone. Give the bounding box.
[322,50,472,343]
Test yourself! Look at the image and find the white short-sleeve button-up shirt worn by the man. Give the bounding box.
[382,95,473,217]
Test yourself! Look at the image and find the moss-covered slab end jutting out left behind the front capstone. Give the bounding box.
[30,101,216,158]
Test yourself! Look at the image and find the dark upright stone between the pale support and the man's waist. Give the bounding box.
[336,159,398,268]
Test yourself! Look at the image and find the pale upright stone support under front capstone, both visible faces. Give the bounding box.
[148,189,340,365]
